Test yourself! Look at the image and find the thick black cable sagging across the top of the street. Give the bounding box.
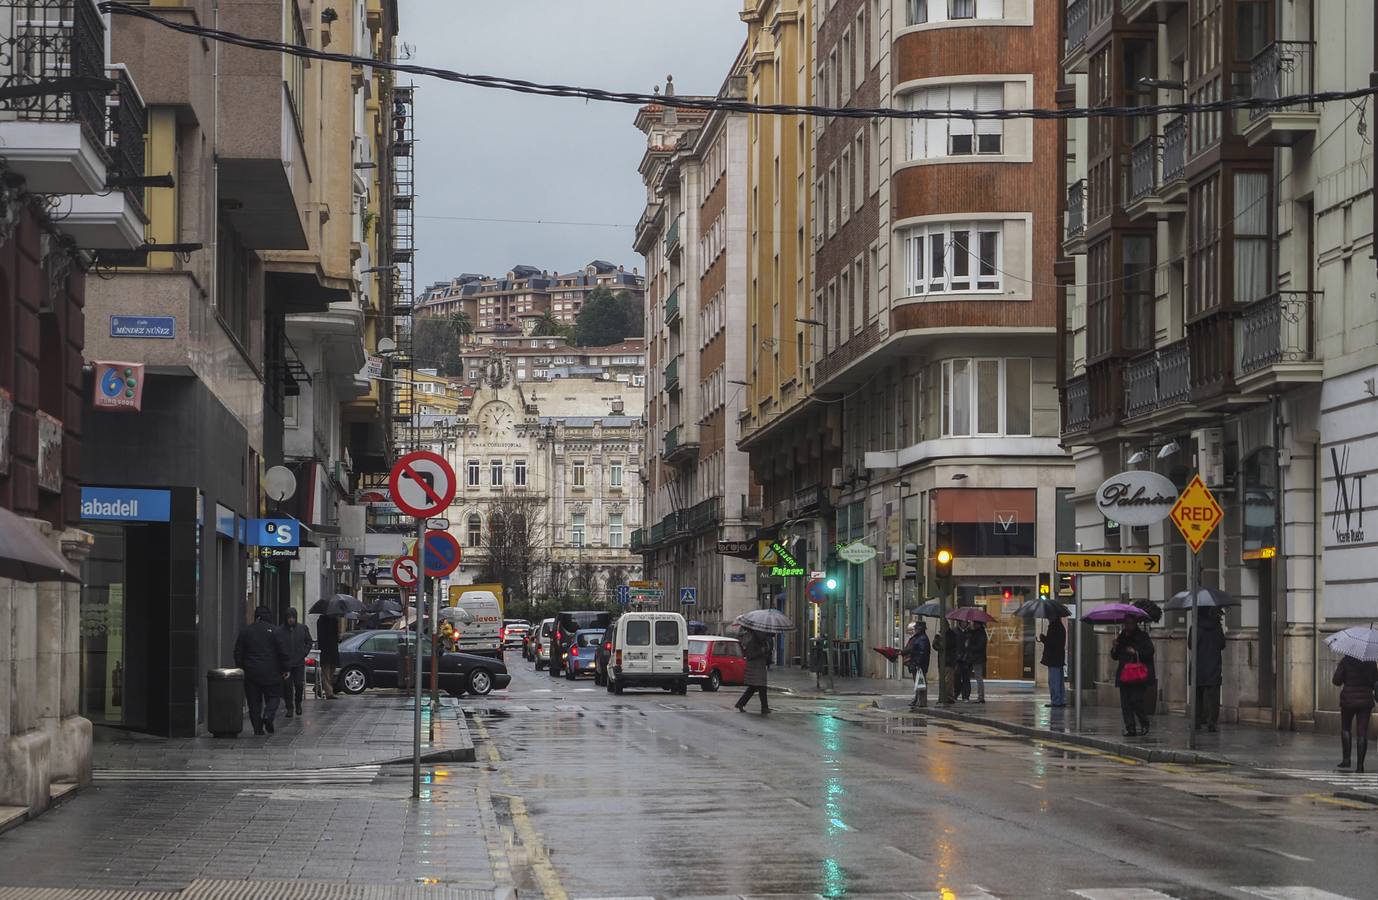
[99,0,1378,120]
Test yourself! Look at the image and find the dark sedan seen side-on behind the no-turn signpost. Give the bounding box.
[307,631,511,696]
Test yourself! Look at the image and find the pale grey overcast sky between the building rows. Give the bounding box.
[400,0,745,291]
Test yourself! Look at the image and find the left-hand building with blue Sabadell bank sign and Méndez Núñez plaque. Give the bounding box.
[81,0,397,736]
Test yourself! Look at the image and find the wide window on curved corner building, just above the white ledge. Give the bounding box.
[943,357,1032,437]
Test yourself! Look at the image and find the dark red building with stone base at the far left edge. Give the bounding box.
[0,0,147,816]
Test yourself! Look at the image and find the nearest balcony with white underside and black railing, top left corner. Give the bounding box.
[0,0,109,194]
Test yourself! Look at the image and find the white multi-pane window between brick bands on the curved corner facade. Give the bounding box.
[904,222,1000,296]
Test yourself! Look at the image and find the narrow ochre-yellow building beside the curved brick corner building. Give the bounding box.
[737,0,821,657]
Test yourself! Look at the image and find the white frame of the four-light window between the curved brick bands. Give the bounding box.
[900,221,1005,296]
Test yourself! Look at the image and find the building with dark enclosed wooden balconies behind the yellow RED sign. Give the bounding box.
[1058,0,1378,728]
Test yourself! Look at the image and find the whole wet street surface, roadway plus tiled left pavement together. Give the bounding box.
[0,653,1378,900]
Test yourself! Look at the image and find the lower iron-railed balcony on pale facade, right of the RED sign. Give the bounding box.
[1235,291,1323,393]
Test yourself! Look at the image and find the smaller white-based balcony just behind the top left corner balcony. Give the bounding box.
[61,66,149,251]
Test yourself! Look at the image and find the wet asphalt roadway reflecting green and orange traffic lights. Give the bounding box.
[469,653,1378,900]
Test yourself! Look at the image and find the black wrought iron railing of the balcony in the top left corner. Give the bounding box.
[0,0,106,152]
